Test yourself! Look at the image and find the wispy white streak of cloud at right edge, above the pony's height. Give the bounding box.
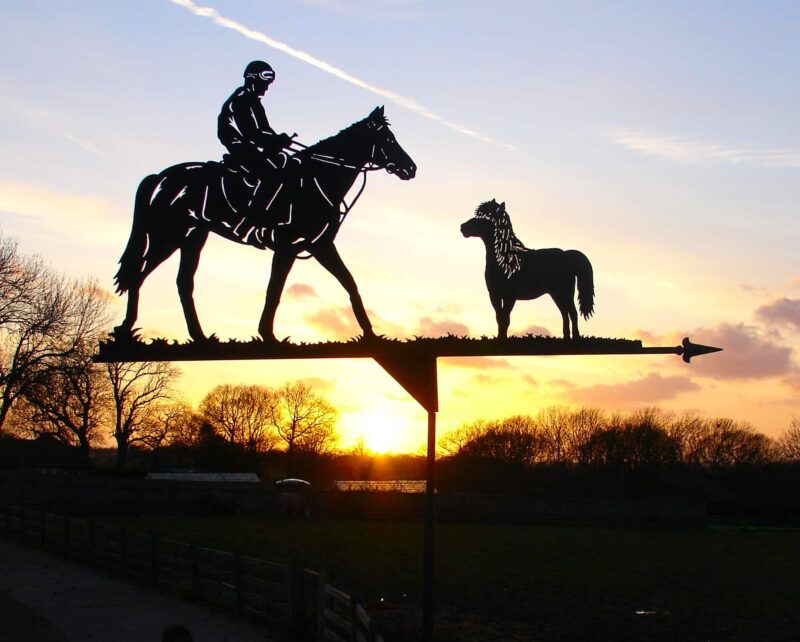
[605,128,800,167]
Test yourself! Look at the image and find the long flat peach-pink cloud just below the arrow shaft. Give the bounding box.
[566,372,700,406]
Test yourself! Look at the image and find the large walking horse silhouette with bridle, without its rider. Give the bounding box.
[115,107,416,341]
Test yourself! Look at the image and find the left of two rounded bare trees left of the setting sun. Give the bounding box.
[200,384,280,453]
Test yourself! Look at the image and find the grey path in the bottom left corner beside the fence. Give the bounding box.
[0,540,281,642]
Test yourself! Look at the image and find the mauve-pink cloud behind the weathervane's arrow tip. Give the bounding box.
[684,323,792,380]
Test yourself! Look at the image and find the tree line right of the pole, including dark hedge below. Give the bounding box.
[438,406,800,497]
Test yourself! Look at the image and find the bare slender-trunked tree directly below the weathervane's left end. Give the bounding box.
[106,361,180,467]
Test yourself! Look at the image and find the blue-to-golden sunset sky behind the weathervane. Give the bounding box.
[0,0,800,451]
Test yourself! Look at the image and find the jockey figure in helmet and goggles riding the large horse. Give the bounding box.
[217,60,294,178]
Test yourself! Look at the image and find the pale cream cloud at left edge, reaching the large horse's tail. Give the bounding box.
[0,181,131,247]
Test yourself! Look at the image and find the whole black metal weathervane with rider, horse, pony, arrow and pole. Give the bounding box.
[96,61,720,640]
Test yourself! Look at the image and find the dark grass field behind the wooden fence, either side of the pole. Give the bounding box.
[109,517,800,642]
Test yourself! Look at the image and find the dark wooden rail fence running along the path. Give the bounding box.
[0,507,383,642]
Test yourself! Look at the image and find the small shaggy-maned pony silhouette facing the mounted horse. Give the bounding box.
[461,199,594,339]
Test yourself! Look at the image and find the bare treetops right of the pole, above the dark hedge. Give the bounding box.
[439,406,800,469]
